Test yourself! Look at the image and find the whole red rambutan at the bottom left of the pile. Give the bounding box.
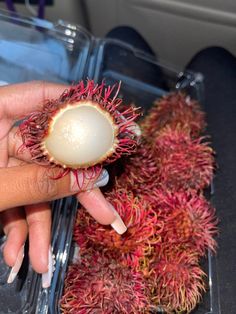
[60,250,149,314]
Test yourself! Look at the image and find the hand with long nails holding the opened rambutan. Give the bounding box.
[0,81,126,287]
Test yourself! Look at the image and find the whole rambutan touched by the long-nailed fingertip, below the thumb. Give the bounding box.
[75,188,163,259]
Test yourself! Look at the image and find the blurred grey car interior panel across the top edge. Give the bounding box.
[0,0,236,69]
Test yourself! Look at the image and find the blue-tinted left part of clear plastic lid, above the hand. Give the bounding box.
[0,11,91,83]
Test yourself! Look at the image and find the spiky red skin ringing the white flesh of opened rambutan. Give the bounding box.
[20,80,138,177]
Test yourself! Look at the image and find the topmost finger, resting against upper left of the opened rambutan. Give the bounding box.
[0,81,66,119]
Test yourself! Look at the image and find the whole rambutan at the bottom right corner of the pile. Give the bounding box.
[149,246,206,313]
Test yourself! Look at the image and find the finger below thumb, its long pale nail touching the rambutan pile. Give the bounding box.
[77,188,127,234]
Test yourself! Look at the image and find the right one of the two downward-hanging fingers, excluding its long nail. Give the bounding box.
[25,203,51,273]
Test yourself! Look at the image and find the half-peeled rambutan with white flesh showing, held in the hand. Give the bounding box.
[20,80,138,180]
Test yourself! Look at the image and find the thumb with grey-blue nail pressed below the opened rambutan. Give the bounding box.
[0,164,107,211]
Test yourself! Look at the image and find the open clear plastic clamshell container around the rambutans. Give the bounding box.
[0,12,220,314]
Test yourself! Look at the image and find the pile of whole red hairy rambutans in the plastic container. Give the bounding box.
[61,92,217,314]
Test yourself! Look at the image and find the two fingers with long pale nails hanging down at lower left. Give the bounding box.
[0,203,53,285]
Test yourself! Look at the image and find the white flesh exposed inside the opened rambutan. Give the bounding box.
[43,101,116,168]
